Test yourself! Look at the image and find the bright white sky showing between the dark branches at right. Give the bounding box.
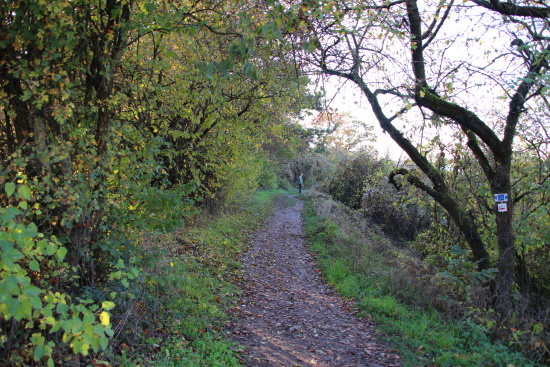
[306,2,548,160]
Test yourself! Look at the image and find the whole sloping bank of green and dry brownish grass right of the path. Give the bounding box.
[304,192,543,367]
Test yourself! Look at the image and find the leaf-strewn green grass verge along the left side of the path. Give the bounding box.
[106,191,288,367]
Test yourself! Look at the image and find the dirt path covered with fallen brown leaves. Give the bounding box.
[234,200,400,367]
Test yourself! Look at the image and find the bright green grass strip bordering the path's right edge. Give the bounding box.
[304,197,534,367]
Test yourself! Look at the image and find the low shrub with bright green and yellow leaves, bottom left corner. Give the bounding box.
[0,183,115,366]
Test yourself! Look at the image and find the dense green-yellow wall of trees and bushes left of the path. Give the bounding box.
[0,0,307,365]
